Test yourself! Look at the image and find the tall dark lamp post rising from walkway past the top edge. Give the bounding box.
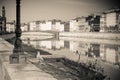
[10,0,23,63]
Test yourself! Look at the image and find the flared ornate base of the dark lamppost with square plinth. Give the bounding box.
[9,37,27,64]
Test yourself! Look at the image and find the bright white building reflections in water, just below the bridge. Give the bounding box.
[23,38,64,50]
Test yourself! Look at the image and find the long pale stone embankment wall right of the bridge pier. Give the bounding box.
[59,32,120,40]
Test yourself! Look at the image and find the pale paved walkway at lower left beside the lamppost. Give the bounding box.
[0,38,57,80]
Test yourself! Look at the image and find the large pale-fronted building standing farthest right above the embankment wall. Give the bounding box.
[100,9,120,32]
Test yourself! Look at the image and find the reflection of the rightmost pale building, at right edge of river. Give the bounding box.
[100,44,120,64]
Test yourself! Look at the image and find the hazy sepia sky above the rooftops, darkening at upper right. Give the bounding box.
[0,0,119,22]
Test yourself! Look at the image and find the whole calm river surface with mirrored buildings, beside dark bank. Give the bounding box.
[23,36,120,80]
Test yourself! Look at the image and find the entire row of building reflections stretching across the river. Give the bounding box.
[23,38,120,64]
